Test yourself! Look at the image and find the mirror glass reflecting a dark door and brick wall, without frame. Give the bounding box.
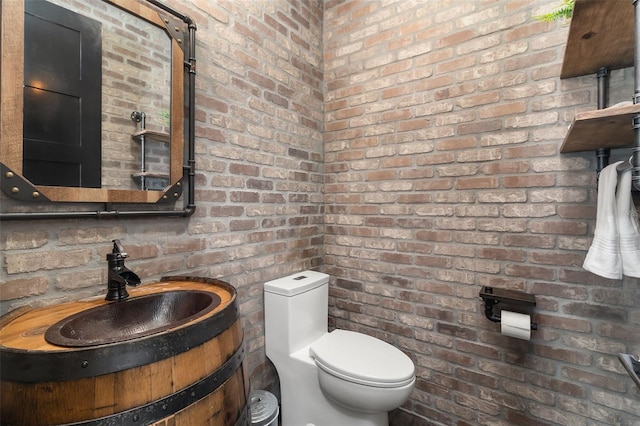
[23,0,171,190]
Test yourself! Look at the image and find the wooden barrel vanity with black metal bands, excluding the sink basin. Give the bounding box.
[0,277,250,426]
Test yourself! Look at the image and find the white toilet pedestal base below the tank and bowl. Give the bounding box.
[267,346,389,426]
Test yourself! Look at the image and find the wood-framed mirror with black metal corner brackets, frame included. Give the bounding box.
[0,0,195,204]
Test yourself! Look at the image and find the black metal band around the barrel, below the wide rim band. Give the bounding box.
[61,341,249,426]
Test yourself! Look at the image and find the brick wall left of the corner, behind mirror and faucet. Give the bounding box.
[0,0,323,388]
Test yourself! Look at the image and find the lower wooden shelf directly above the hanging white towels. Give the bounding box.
[560,105,640,152]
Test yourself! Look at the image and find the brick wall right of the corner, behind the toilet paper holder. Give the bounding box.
[324,0,640,426]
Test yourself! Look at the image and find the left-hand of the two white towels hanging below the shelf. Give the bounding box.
[582,161,622,280]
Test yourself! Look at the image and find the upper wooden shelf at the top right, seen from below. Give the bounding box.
[560,0,635,78]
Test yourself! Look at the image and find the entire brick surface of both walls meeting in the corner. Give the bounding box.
[5,0,640,426]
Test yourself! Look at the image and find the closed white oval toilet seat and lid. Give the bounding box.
[309,330,415,388]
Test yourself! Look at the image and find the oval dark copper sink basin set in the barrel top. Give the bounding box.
[44,290,220,347]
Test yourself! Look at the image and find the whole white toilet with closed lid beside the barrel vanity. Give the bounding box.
[264,271,416,426]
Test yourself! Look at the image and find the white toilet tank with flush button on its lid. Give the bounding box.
[264,271,329,360]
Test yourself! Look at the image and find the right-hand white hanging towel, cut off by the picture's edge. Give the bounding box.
[616,169,640,278]
